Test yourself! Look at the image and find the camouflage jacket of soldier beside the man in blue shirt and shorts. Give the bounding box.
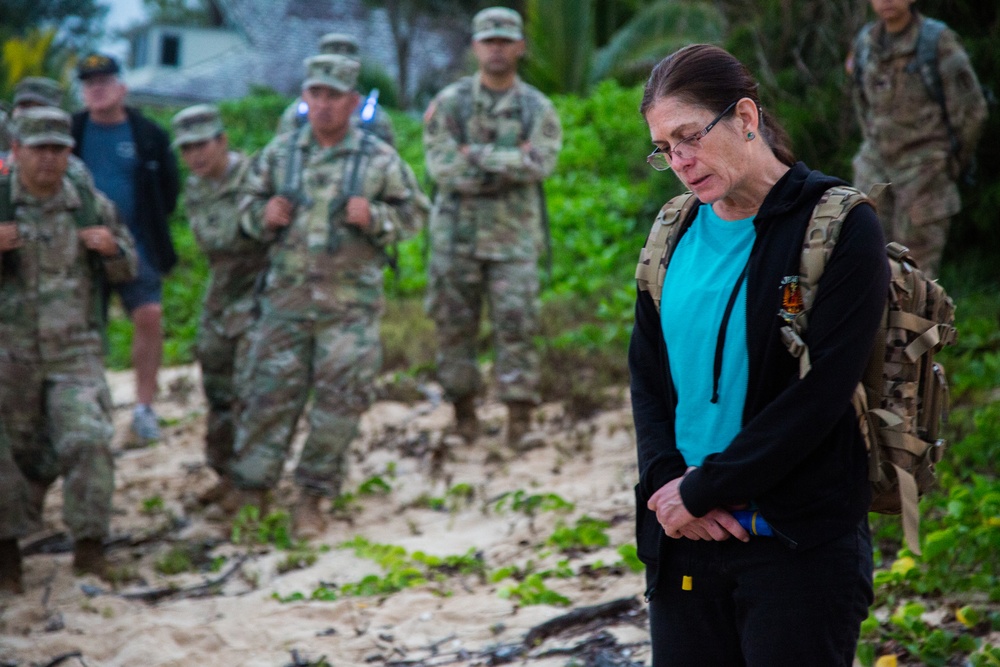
[184,152,267,338]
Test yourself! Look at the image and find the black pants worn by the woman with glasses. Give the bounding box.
[649,520,873,667]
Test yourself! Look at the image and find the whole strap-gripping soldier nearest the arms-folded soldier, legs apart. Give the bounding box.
[227,55,429,537]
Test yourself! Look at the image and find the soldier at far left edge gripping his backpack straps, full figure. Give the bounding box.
[0,107,136,588]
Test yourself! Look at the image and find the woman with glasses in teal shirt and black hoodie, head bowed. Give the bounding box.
[629,45,888,667]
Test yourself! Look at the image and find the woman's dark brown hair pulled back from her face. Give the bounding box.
[639,44,795,166]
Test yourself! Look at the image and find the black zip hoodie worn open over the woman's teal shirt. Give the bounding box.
[629,162,889,584]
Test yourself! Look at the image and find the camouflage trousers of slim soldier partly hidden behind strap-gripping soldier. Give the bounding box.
[196,319,249,476]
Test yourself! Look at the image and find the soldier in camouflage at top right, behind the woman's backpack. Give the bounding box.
[848,0,986,277]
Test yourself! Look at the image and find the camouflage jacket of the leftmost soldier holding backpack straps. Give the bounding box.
[0,166,137,361]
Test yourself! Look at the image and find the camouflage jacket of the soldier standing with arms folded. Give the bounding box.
[424,76,562,261]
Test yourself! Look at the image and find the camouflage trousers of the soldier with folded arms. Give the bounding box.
[427,253,541,403]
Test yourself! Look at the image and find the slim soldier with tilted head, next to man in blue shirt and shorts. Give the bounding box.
[172,104,267,502]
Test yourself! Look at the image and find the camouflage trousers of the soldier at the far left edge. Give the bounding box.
[0,349,114,540]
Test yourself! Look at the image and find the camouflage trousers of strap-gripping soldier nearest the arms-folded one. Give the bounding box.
[230,309,382,496]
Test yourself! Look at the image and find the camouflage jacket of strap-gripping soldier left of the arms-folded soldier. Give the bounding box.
[240,125,430,319]
